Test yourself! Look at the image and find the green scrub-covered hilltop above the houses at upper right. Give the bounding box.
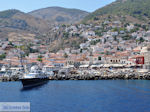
[84,0,150,22]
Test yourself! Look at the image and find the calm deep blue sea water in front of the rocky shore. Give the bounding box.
[0,80,150,112]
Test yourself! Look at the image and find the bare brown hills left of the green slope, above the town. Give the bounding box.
[0,7,88,38]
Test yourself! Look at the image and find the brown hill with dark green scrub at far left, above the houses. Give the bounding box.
[0,9,49,41]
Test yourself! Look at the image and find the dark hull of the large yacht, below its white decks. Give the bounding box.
[20,78,48,88]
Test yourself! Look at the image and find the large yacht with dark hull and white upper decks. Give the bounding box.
[20,66,49,88]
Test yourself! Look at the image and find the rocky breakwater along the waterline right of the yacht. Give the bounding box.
[50,70,150,80]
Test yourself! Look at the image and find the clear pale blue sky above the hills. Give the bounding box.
[0,0,115,12]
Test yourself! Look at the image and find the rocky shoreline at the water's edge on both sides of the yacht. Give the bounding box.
[0,69,150,81]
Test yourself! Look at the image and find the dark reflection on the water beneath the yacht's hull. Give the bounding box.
[21,80,49,92]
